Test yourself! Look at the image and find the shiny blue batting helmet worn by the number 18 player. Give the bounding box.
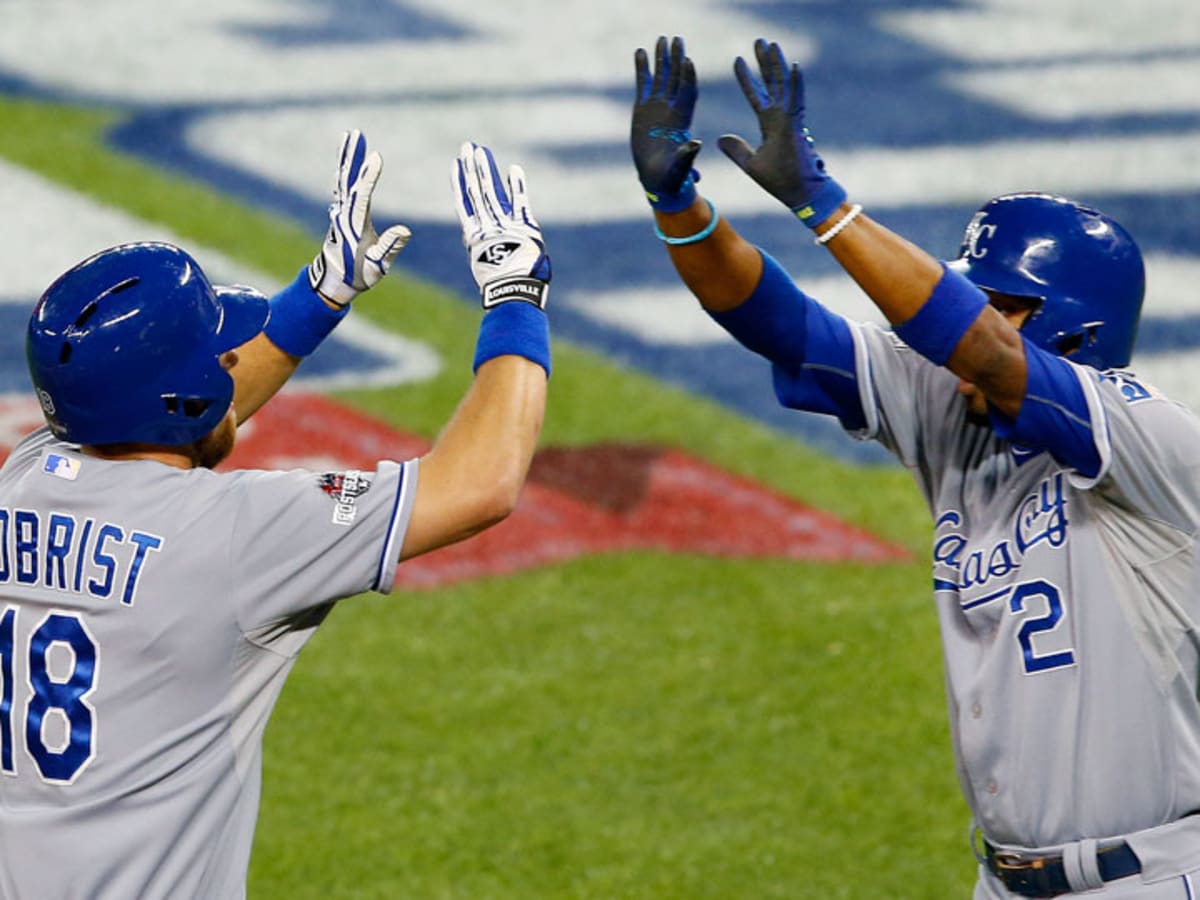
[25,242,268,445]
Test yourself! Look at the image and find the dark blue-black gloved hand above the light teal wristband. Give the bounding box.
[630,37,700,212]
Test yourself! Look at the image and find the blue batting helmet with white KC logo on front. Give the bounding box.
[950,193,1146,370]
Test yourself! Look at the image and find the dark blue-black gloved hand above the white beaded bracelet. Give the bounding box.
[718,37,846,228]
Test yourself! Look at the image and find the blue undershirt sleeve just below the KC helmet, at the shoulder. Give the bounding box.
[990,341,1100,478]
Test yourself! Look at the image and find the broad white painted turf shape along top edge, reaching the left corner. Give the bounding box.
[0,0,814,102]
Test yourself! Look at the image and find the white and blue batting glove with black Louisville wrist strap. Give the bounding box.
[450,142,550,310]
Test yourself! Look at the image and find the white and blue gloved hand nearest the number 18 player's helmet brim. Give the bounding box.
[308,130,413,306]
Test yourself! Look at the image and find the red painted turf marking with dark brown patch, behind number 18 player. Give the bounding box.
[0,392,908,588]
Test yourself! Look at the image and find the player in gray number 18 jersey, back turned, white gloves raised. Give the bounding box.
[0,132,550,900]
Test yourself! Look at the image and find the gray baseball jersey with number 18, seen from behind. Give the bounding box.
[0,430,418,900]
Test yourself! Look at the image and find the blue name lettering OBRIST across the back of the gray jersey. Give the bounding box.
[0,506,163,606]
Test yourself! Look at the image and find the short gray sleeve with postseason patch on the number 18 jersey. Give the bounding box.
[230,460,419,631]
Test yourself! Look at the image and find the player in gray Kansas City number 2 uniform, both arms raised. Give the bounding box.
[631,38,1200,900]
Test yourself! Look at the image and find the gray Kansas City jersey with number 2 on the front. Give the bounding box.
[853,325,1200,848]
